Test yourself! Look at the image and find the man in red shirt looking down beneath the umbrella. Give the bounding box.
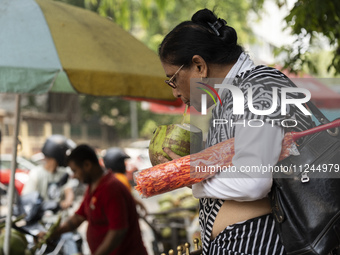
[51,145,147,255]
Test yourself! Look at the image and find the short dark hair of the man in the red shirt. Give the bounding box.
[67,144,99,167]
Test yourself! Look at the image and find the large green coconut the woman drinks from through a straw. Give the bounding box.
[149,123,202,166]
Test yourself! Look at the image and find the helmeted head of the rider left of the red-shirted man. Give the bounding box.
[41,135,76,172]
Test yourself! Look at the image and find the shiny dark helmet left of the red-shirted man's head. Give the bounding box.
[41,135,76,166]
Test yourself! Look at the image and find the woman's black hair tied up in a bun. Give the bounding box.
[158,9,243,66]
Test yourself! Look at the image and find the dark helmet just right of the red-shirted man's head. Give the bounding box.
[103,147,130,173]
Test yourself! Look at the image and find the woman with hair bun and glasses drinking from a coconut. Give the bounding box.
[159,9,311,255]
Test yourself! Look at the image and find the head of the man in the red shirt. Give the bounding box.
[67,144,102,184]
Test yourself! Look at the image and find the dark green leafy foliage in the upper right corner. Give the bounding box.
[274,0,340,74]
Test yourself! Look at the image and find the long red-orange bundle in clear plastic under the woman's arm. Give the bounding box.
[135,119,340,197]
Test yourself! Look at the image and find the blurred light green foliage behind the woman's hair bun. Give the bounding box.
[84,0,255,51]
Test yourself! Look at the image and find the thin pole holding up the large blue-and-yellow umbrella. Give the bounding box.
[4,94,21,255]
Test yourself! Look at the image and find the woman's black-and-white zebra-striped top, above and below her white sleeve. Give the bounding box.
[199,66,311,255]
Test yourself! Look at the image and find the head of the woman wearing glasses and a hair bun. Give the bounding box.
[158,9,243,110]
